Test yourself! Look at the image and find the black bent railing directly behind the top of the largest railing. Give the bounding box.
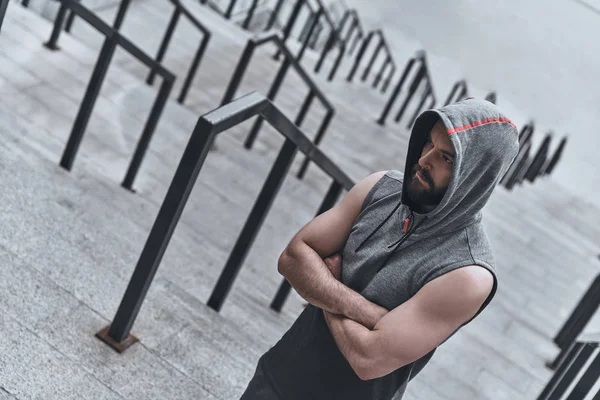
[221,32,335,179]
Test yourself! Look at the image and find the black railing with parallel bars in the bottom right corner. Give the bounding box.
[537,334,600,400]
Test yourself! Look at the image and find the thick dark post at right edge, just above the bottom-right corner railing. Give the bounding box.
[554,275,600,349]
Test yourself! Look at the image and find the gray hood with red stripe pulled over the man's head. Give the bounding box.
[402,98,519,236]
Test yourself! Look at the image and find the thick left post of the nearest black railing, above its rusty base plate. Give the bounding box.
[108,118,215,343]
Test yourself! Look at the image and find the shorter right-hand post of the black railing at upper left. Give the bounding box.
[121,78,173,191]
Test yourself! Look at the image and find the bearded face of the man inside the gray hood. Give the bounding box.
[407,121,456,212]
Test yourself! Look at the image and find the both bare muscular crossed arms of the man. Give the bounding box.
[278,172,493,380]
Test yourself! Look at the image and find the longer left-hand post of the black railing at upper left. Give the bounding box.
[60,37,117,171]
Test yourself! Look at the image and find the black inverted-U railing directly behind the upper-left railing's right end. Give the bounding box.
[146,0,211,104]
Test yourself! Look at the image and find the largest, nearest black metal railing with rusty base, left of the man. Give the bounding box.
[96,92,354,352]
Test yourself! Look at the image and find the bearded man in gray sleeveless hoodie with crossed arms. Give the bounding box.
[242,99,518,400]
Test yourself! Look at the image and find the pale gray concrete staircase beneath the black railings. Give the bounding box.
[0,0,600,400]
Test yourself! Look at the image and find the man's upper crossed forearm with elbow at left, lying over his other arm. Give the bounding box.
[279,243,387,329]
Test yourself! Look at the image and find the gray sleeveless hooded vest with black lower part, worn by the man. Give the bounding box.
[259,99,518,400]
